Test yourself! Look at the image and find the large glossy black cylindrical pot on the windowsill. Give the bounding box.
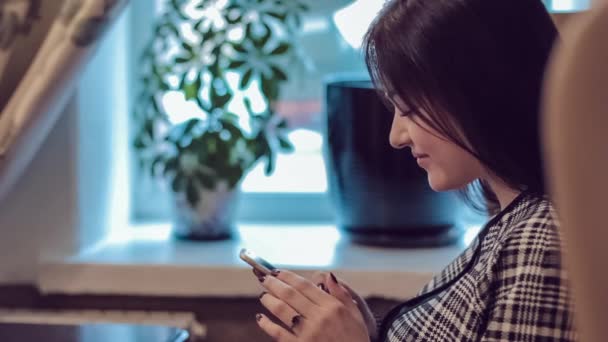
[324,80,462,247]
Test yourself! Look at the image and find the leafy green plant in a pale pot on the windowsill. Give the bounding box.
[133,0,307,239]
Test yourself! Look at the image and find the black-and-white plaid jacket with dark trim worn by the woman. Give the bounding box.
[380,193,576,342]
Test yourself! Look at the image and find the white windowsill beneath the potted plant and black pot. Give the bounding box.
[38,224,477,299]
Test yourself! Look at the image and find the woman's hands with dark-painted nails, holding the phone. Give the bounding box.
[256,270,369,342]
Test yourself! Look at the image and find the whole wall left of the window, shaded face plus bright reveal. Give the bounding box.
[0,2,129,285]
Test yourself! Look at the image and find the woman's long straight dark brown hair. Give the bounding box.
[363,0,557,214]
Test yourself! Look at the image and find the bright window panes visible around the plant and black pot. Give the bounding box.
[130,0,589,222]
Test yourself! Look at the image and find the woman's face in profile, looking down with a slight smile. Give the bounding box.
[389,96,484,191]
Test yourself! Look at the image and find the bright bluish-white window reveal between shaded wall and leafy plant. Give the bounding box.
[78,2,132,246]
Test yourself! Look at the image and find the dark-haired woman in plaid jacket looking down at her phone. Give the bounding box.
[248,0,576,342]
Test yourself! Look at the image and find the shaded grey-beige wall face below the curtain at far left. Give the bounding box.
[0,100,78,284]
